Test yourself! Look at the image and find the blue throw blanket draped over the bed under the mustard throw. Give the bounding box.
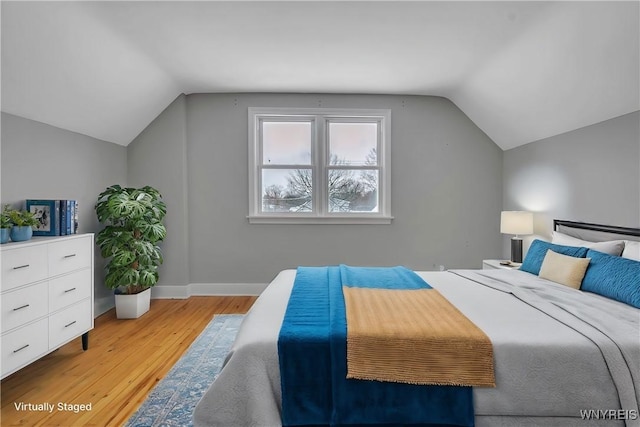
[278,265,474,427]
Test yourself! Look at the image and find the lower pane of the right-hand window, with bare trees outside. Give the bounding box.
[329,169,378,212]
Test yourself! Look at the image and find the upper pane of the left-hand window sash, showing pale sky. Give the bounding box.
[262,122,311,165]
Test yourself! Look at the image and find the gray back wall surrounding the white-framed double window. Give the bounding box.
[178,94,502,283]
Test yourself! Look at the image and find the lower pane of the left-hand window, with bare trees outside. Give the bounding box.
[262,169,313,212]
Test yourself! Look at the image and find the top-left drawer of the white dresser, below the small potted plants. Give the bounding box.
[2,245,48,292]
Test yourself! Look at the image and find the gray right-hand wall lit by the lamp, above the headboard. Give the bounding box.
[503,112,640,256]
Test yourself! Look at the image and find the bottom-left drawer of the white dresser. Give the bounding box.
[2,319,49,378]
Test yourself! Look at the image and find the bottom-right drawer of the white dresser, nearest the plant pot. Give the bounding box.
[49,299,93,348]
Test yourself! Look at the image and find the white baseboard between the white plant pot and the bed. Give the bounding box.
[151,283,268,299]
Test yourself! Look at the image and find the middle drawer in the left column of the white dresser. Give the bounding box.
[2,282,49,332]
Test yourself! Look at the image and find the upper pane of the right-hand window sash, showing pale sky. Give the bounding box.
[329,122,378,166]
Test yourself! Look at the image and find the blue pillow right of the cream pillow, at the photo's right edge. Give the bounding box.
[580,249,640,308]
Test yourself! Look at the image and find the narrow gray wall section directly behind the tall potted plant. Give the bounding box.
[127,95,189,286]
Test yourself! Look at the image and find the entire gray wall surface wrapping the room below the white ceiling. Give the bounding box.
[0,98,640,300]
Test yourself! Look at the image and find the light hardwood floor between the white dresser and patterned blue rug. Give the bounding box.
[0,297,256,427]
